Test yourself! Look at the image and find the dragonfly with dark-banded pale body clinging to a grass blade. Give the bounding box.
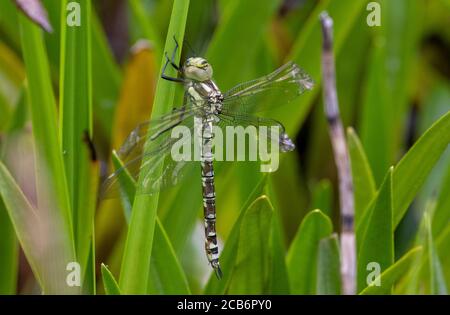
[102,40,314,279]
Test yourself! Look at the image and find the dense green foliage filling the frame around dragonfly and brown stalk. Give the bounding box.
[0,0,450,294]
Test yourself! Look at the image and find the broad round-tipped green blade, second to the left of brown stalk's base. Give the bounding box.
[286,210,333,294]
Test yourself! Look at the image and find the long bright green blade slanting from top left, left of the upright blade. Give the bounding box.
[19,6,75,256]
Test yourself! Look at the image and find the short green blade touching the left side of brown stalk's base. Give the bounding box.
[316,234,341,294]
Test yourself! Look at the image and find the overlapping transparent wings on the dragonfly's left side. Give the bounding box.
[101,106,201,199]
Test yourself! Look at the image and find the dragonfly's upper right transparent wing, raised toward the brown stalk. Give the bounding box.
[223,62,314,113]
